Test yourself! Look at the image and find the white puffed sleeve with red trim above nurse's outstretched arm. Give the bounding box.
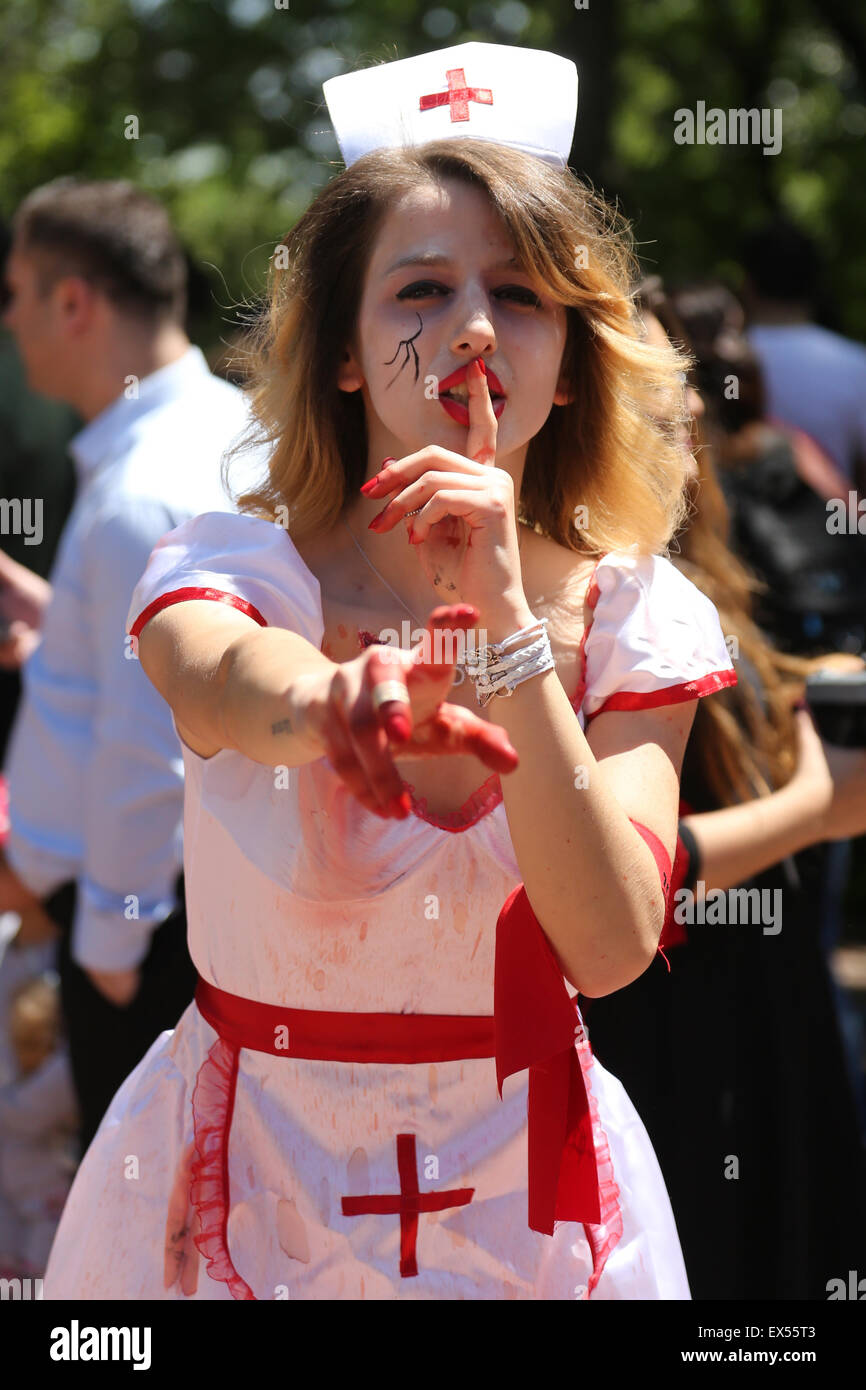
[126,512,324,646]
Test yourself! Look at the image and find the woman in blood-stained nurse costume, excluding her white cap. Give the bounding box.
[44,95,735,1298]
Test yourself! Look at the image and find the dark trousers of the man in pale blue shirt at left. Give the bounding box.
[44,873,196,1154]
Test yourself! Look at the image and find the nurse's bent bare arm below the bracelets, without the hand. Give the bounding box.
[489,597,696,998]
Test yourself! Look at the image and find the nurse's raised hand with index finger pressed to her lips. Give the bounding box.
[366,359,528,628]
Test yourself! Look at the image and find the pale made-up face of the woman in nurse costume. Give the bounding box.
[338,179,567,478]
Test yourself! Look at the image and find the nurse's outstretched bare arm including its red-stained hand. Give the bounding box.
[139,599,517,819]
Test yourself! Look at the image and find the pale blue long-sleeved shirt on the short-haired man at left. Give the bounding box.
[6,348,264,970]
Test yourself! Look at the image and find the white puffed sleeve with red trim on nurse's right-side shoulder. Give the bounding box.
[582,552,737,721]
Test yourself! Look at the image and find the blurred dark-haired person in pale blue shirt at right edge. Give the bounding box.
[744,221,866,489]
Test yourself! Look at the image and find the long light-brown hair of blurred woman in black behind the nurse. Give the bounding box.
[637,275,815,810]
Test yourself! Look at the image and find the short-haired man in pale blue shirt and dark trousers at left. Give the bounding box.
[0,179,258,1141]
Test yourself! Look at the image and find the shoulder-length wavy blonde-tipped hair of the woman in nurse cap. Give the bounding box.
[224,138,688,555]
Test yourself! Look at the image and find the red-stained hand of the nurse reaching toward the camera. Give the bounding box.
[284,603,518,820]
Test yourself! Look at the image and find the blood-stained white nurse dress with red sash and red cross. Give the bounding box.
[44,513,737,1300]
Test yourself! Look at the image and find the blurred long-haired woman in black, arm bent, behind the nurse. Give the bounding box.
[581,278,866,1300]
